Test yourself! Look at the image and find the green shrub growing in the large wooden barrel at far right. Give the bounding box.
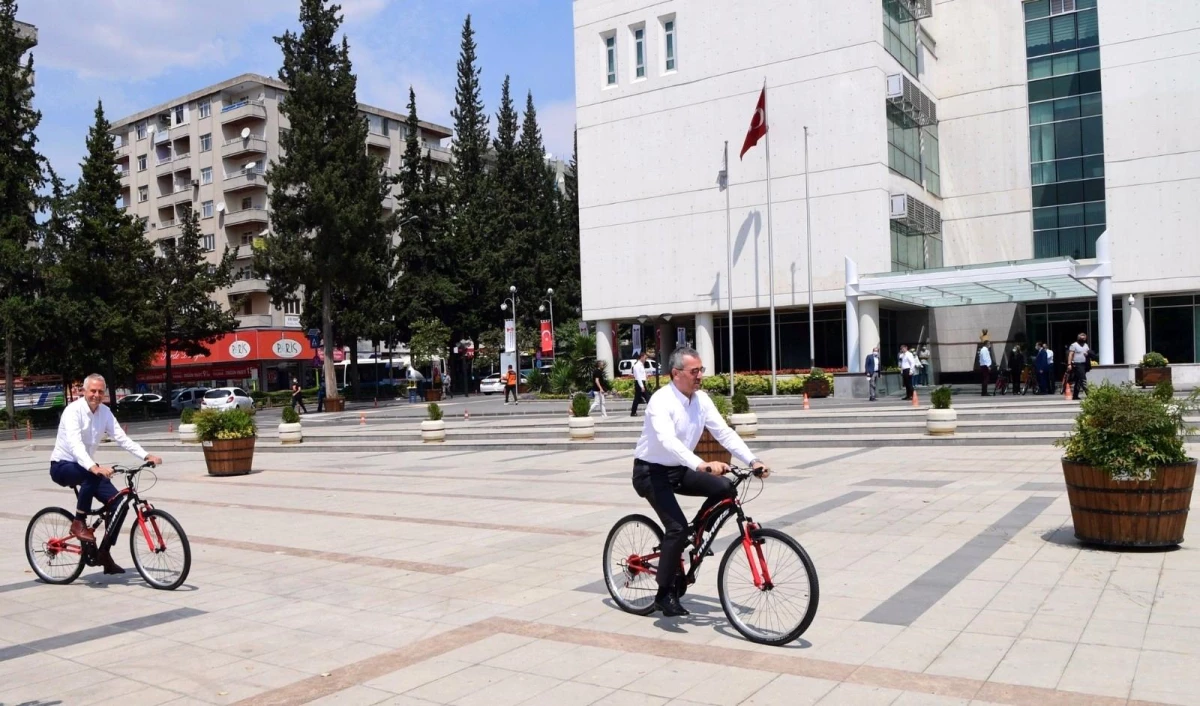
[1055,382,1200,479]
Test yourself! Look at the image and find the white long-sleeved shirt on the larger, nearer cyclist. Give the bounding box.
[634,383,755,471]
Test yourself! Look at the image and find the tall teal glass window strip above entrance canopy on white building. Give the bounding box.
[1024,0,1106,258]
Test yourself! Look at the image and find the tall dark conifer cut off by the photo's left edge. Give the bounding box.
[0,0,43,425]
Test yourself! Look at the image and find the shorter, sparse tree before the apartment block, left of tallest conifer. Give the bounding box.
[154,209,238,399]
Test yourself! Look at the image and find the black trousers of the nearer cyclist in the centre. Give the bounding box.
[634,460,734,598]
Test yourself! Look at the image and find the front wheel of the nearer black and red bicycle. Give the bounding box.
[716,527,820,645]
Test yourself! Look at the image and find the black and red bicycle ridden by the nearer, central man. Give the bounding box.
[604,467,820,645]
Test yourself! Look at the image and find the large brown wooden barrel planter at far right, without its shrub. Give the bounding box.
[1062,460,1196,546]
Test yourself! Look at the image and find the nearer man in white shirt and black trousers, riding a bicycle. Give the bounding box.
[634,347,770,617]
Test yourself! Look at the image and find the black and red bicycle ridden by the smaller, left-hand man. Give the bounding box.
[25,463,192,591]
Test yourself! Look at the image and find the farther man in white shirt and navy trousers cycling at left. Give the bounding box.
[50,373,162,574]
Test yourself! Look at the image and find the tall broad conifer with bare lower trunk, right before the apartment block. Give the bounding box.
[254,0,396,400]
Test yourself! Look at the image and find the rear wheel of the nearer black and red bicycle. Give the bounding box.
[604,515,662,615]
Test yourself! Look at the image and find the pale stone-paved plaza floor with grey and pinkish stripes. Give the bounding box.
[0,442,1200,706]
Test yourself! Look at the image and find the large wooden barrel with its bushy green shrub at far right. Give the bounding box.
[1055,382,1200,548]
